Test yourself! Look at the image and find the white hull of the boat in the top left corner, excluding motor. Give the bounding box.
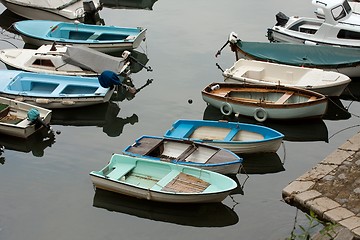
[1,0,84,22]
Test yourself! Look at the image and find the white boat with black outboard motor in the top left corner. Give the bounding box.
[0,0,99,22]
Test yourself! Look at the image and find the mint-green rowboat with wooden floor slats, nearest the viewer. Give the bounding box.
[90,154,237,203]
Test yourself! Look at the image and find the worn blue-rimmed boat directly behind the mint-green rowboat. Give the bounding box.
[122,135,242,175]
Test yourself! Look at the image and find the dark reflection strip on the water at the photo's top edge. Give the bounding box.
[100,0,157,10]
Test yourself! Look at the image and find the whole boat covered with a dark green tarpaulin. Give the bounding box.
[222,32,360,78]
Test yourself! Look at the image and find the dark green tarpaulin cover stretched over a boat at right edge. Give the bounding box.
[236,40,360,67]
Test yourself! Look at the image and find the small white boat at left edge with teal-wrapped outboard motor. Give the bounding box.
[0,97,51,138]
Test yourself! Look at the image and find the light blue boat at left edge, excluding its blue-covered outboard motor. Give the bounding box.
[0,70,114,109]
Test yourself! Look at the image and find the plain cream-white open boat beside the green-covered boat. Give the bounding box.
[223,59,351,96]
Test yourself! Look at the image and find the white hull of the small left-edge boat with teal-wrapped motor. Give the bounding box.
[0,97,51,138]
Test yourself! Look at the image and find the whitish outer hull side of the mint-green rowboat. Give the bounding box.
[90,175,229,203]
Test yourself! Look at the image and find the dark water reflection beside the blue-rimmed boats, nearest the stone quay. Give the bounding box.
[241,153,285,174]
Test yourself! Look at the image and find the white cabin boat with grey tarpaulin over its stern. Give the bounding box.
[0,44,130,77]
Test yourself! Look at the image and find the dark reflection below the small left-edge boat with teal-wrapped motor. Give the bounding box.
[0,125,55,164]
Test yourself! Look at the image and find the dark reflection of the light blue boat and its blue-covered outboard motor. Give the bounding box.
[51,102,139,137]
